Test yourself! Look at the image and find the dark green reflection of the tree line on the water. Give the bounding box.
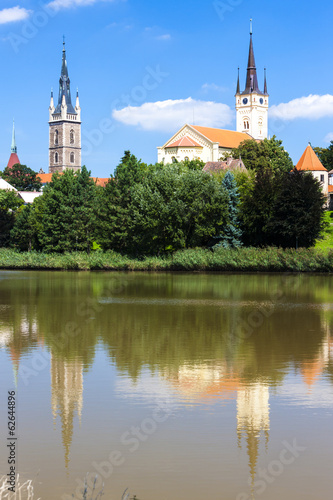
[0,272,333,383]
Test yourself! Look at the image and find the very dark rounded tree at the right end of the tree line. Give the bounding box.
[269,169,325,248]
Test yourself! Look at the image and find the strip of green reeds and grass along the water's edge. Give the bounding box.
[0,244,333,273]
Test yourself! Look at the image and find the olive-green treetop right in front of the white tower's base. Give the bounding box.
[232,136,293,172]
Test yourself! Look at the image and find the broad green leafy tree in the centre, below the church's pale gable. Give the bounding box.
[130,163,228,254]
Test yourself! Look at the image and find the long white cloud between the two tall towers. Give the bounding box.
[112,97,234,132]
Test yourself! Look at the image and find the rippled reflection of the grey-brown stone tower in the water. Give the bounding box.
[51,355,83,468]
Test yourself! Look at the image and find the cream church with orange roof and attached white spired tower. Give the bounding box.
[157,23,269,164]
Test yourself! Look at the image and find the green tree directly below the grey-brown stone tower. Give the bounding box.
[38,167,97,252]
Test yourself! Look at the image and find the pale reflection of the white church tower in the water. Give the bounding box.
[237,381,269,484]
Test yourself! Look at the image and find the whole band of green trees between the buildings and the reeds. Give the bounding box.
[0,137,325,257]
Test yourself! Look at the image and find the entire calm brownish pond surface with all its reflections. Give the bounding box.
[0,272,333,500]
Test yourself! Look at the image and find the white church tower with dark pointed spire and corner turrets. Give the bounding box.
[235,20,269,139]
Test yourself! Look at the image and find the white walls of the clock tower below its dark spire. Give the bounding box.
[236,93,268,140]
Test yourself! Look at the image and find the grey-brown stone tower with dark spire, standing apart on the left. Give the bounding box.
[49,40,81,173]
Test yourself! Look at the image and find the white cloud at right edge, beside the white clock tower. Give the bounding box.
[269,94,333,121]
